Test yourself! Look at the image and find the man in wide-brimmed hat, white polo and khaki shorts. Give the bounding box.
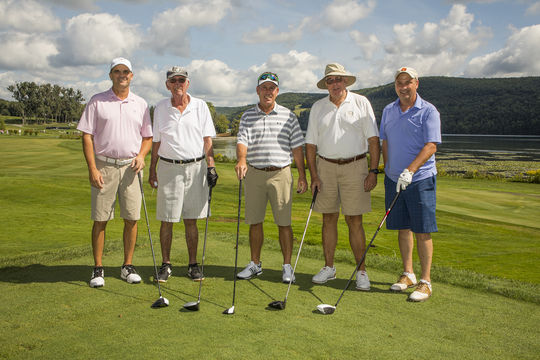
[306,63,380,291]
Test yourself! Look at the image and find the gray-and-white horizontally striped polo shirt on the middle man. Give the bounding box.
[237,103,304,167]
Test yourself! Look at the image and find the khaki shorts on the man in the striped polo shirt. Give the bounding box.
[244,166,293,226]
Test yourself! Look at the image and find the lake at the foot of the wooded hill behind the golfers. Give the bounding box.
[214,135,540,161]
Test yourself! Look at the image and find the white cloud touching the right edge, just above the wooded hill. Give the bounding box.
[465,25,540,77]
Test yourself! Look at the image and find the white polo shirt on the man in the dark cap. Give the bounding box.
[153,94,216,160]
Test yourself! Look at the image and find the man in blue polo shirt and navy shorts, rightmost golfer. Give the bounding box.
[380,67,441,302]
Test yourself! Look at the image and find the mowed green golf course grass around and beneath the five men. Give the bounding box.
[0,137,540,359]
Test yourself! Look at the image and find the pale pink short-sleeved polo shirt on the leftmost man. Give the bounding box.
[77,88,152,159]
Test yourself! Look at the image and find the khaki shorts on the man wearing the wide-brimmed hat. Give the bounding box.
[313,157,371,216]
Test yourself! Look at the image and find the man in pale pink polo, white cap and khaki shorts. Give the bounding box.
[77,58,152,287]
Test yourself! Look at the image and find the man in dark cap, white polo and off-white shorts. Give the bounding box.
[149,66,218,282]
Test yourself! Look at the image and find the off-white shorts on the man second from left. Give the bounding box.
[156,161,208,222]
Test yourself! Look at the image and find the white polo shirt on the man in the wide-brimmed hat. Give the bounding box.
[306,91,379,159]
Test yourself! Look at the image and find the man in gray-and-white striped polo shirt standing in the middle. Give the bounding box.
[235,72,307,283]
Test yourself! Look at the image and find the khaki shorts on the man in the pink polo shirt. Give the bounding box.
[91,159,142,221]
